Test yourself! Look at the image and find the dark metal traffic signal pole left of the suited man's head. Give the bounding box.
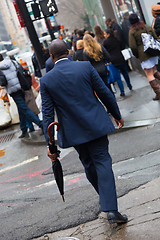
[16,0,45,68]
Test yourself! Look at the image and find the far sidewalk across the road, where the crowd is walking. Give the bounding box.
[22,72,160,144]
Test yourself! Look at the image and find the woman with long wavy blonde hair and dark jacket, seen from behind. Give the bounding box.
[83,34,112,92]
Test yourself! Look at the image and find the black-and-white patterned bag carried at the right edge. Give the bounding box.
[141,26,160,57]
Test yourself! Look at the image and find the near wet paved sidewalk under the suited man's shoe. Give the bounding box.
[34,178,160,240]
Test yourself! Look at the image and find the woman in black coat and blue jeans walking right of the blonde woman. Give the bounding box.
[103,30,132,96]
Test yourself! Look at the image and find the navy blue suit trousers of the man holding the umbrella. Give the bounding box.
[75,136,118,212]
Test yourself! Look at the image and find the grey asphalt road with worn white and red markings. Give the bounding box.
[0,124,160,240]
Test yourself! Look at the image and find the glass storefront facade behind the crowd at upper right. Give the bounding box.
[83,0,157,29]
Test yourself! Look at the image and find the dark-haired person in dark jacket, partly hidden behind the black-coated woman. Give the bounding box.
[106,18,125,50]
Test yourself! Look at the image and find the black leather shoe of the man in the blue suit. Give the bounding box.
[107,211,128,224]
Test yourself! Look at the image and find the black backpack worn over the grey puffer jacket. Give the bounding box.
[12,61,32,91]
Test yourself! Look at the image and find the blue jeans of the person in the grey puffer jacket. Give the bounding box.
[12,91,43,132]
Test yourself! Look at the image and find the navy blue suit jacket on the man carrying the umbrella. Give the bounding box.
[40,60,121,148]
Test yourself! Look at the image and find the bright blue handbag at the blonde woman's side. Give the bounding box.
[105,62,121,84]
